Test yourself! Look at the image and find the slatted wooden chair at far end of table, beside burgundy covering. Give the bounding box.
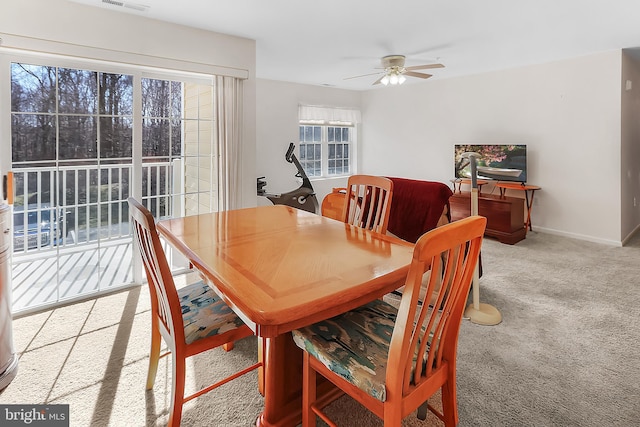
[341,175,393,234]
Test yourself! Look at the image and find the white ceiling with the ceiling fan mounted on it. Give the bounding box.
[72,0,640,90]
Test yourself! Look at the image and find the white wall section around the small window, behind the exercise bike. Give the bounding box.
[254,79,361,205]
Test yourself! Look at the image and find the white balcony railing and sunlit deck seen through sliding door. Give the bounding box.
[12,161,180,312]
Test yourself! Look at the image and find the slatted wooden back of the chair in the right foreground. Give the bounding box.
[385,216,487,425]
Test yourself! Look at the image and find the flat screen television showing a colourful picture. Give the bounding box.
[454,144,527,183]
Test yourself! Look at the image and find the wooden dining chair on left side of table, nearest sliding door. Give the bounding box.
[128,198,262,426]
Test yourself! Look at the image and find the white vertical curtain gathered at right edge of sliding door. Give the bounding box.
[214,76,243,210]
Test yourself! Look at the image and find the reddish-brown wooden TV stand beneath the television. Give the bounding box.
[449,191,527,245]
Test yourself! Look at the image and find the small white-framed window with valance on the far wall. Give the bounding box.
[299,106,359,178]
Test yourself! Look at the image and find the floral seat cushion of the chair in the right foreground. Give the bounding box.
[292,300,397,402]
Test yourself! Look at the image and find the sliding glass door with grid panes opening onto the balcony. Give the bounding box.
[0,56,218,312]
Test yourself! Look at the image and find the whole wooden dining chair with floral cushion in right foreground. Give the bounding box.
[293,216,487,427]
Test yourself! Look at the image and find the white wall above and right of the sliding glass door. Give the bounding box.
[0,0,256,206]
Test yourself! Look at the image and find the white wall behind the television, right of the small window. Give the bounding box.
[362,51,624,245]
